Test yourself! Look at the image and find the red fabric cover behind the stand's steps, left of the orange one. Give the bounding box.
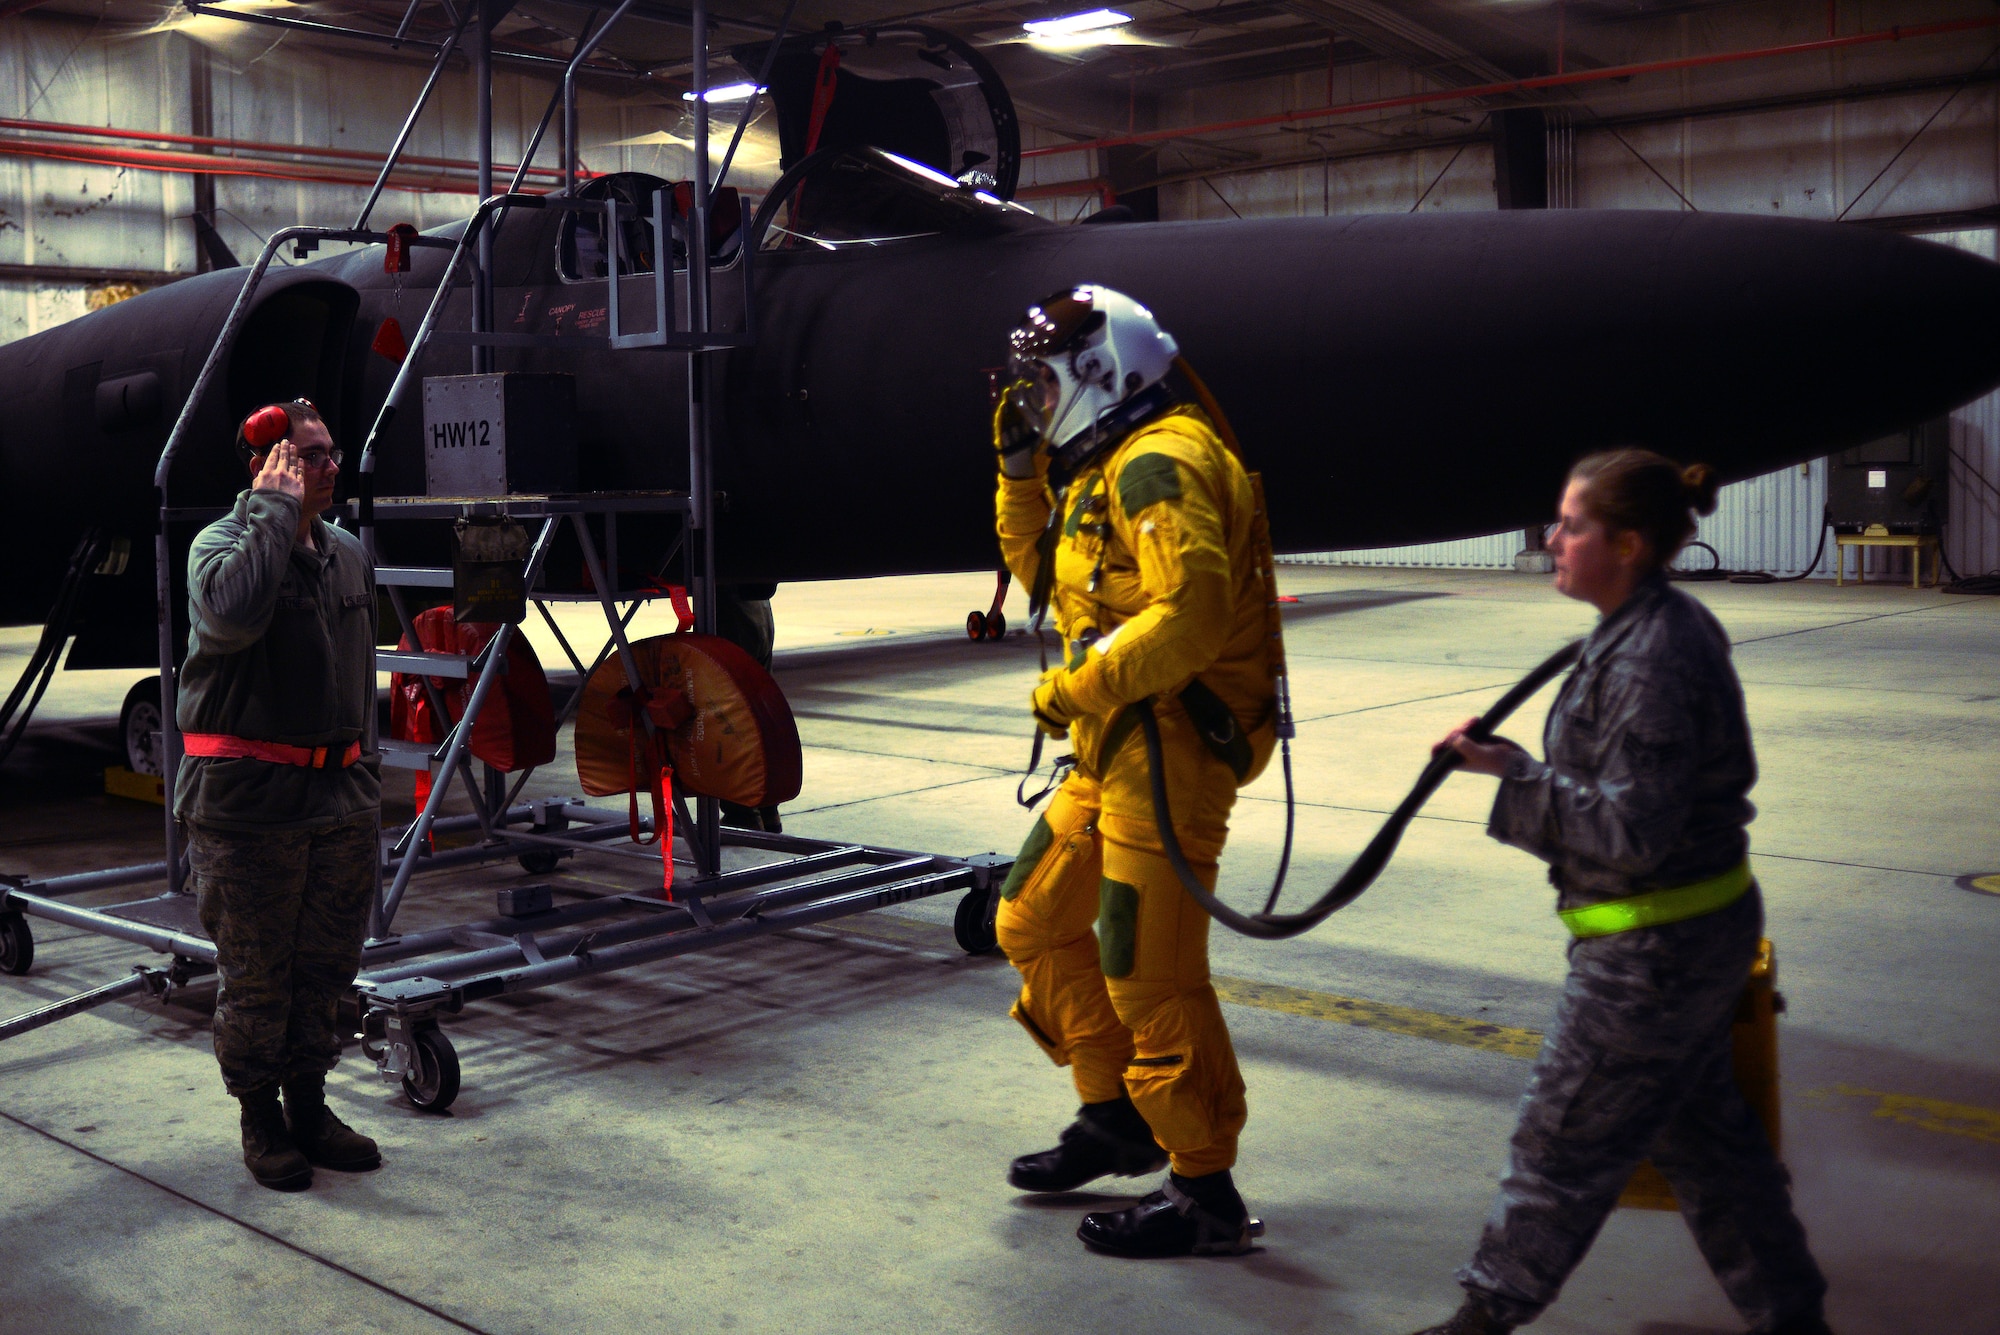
[388,608,556,771]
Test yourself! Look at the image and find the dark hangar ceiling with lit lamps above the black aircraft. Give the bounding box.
[11,0,1990,178]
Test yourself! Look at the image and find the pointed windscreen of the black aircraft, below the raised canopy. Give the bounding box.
[758,148,1048,252]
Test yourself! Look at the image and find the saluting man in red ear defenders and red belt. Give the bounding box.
[174,404,382,1191]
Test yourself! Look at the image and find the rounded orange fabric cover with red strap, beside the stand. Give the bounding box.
[576,632,804,807]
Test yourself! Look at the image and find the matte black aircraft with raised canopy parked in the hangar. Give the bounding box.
[0,28,2000,668]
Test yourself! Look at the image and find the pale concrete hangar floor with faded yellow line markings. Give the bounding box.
[0,568,2000,1335]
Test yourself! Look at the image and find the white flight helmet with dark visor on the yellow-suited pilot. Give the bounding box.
[1008,284,1180,454]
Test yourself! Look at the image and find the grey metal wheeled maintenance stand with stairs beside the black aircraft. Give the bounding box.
[0,0,1012,1111]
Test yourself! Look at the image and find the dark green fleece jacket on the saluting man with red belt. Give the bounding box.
[174,492,382,829]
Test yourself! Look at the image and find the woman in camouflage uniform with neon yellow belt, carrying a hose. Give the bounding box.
[1424,450,1826,1335]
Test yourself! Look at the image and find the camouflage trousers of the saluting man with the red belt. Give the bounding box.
[188,813,378,1095]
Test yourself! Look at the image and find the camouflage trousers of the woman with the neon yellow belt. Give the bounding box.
[1458,887,1826,1331]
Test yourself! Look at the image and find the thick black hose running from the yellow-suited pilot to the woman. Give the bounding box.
[1132,640,1584,941]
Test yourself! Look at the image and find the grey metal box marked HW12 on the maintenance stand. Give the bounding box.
[424,372,576,496]
